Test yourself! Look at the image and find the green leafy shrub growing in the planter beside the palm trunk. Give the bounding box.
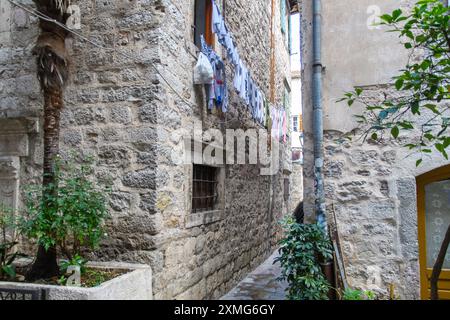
[20,159,108,262]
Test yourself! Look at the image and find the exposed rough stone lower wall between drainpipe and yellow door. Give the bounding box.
[316,133,428,299]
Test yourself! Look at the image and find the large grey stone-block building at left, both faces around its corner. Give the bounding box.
[0,0,291,299]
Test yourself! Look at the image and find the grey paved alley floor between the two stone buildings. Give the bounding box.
[221,251,287,300]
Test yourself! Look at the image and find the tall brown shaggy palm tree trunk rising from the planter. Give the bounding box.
[27,0,70,281]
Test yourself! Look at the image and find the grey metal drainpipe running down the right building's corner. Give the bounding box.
[312,0,328,235]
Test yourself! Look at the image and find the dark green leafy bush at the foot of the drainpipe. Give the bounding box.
[276,218,332,300]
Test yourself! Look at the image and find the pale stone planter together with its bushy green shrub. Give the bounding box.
[0,160,152,300]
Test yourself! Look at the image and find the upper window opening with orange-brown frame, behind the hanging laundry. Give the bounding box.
[194,0,214,48]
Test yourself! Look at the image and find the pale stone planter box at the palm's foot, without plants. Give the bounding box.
[0,263,153,300]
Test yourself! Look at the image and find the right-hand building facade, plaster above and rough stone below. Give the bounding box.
[300,0,450,299]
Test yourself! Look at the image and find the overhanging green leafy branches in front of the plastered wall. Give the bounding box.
[340,0,450,166]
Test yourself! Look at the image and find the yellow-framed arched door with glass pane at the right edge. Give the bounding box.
[417,165,450,300]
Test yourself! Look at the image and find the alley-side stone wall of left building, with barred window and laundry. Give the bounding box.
[154,1,289,299]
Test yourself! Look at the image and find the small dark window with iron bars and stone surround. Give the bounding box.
[192,164,218,213]
